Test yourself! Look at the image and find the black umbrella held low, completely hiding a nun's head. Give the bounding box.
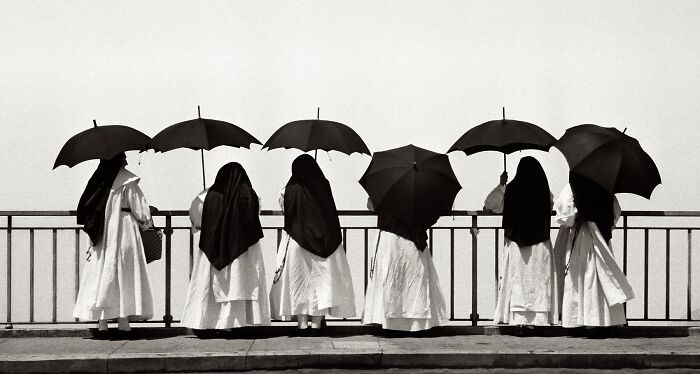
[360,144,462,226]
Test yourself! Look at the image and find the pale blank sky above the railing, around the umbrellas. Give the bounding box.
[0,0,700,210]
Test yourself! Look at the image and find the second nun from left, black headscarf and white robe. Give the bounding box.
[180,162,270,330]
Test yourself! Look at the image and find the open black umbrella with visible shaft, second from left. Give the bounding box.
[148,105,261,188]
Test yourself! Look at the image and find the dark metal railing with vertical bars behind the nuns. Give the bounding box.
[0,210,700,328]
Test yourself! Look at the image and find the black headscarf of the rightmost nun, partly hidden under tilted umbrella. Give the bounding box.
[569,173,615,241]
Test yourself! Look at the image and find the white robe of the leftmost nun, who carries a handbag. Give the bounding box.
[73,168,153,320]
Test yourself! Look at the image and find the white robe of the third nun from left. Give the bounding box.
[270,189,357,321]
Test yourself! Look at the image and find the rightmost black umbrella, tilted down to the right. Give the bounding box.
[554,124,661,199]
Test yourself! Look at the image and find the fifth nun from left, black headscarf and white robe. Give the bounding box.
[493,156,559,327]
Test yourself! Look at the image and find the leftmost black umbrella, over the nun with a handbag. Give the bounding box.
[53,120,151,169]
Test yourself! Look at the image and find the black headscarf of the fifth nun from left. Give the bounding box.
[503,156,552,247]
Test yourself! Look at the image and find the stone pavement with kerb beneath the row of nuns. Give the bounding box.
[0,326,700,373]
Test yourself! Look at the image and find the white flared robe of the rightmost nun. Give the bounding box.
[554,184,635,327]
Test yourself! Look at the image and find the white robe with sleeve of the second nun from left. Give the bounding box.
[180,190,270,330]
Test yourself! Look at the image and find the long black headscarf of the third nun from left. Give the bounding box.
[284,154,343,257]
